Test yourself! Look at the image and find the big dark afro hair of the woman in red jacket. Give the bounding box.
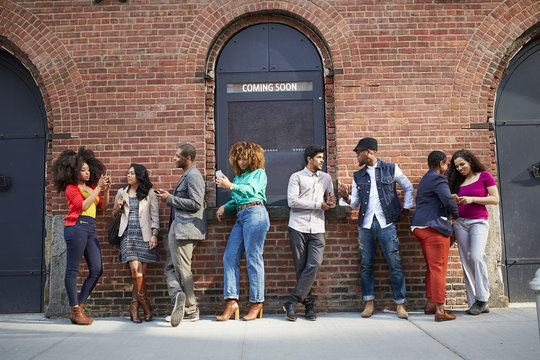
[51,147,105,192]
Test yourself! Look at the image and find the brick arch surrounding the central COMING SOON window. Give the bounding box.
[178,1,356,204]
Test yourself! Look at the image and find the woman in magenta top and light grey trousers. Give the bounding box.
[448,150,499,315]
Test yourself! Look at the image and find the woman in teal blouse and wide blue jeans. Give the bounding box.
[216,141,270,321]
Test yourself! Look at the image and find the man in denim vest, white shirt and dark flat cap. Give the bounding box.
[338,138,413,319]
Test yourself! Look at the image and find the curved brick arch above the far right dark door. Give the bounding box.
[451,0,540,148]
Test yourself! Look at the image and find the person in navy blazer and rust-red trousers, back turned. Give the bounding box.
[411,151,458,321]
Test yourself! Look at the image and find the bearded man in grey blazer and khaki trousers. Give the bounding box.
[157,144,207,327]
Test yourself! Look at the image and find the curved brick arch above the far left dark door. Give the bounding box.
[0,0,88,137]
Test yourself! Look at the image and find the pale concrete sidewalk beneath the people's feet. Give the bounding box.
[0,304,540,360]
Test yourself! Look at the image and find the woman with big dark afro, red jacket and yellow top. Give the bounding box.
[52,147,111,325]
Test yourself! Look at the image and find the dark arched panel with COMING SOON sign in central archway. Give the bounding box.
[216,23,326,205]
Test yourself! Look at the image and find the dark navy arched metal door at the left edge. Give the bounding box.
[0,50,47,313]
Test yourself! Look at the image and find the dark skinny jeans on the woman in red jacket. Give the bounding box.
[64,215,103,306]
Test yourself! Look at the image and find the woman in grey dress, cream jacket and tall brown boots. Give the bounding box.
[113,164,159,323]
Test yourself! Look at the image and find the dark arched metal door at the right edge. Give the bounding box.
[495,40,540,302]
